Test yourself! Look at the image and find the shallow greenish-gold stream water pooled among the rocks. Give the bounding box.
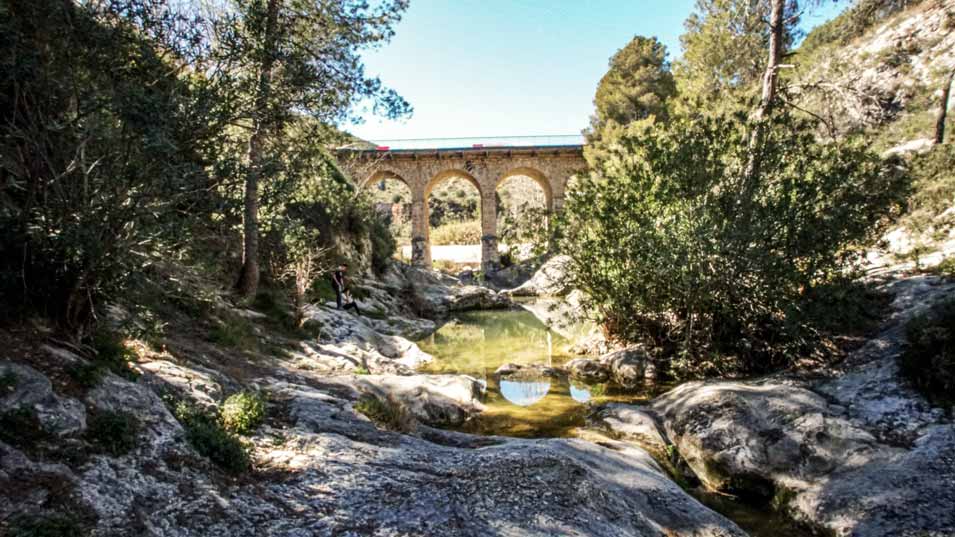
[418,310,811,537]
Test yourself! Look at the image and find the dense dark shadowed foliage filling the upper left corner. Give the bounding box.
[0,0,218,333]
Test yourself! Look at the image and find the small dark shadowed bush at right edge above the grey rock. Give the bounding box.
[901,299,955,406]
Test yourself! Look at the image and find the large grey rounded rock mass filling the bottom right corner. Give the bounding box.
[652,276,955,537]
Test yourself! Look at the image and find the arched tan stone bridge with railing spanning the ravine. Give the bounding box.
[337,137,585,273]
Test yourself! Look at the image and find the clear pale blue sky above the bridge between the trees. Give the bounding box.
[346,0,844,140]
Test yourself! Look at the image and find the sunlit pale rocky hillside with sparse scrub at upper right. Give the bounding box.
[789,0,955,265]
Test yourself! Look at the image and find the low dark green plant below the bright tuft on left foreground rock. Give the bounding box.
[173,401,252,474]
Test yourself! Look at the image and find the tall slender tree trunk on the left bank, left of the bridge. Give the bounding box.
[236,0,280,299]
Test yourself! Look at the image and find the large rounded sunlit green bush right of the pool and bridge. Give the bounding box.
[563,110,908,374]
